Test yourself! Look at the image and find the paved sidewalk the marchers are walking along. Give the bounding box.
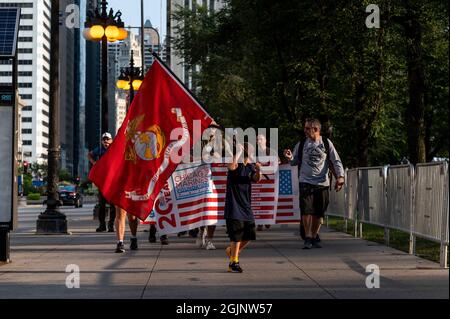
[0,205,449,299]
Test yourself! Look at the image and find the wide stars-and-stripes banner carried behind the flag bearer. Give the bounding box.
[144,163,300,235]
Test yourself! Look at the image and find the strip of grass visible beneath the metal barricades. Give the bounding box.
[328,216,441,262]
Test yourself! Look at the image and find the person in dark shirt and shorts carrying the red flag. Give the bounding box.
[224,143,261,273]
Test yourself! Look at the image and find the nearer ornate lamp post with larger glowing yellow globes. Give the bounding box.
[83,0,128,133]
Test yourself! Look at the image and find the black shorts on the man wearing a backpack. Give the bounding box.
[299,183,330,218]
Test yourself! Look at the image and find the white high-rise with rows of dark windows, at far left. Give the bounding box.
[0,0,51,163]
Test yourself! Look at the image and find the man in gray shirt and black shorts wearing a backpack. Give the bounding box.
[284,119,345,249]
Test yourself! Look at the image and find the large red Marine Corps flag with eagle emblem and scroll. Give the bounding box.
[89,59,212,220]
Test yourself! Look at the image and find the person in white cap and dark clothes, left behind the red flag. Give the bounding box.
[87,133,116,233]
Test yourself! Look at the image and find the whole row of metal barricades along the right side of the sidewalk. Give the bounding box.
[326,162,449,267]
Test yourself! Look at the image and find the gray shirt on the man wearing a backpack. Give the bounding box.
[291,137,345,186]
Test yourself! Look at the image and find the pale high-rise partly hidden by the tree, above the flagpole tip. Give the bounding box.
[165,0,225,89]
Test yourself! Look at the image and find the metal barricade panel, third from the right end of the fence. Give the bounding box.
[357,166,387,227]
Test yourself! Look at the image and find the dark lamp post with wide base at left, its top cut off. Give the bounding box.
[36,0,67,234]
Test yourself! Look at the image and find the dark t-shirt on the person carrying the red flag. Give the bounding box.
[224,163,256,221]
